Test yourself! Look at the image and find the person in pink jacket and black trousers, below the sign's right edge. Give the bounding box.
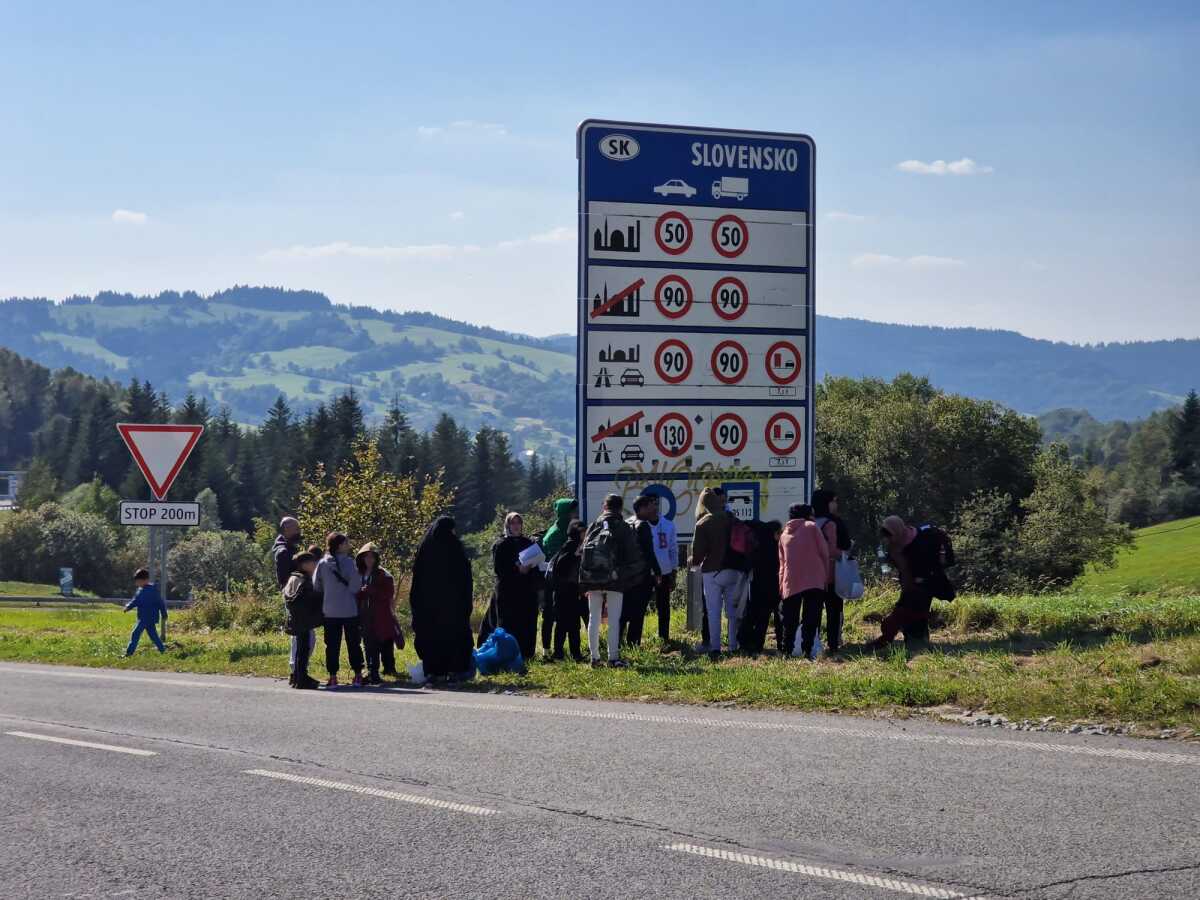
[779,503,829,659]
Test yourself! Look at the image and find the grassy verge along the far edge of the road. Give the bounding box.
[0,593,1200,732]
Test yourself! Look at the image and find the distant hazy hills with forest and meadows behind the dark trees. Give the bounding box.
[0,287,1200,434]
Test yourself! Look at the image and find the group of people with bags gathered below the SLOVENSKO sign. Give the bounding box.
[262,487,934,689]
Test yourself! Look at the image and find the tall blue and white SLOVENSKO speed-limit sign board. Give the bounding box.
[576,120,815,540]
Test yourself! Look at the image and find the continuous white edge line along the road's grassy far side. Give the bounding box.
[0,664,1200,767]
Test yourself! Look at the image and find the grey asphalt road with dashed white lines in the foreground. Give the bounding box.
[0,664,1200,900]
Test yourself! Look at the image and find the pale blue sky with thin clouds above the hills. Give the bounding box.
[0,1,1200,341]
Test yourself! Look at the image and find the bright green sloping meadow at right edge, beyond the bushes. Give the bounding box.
[1076,516,1200,593]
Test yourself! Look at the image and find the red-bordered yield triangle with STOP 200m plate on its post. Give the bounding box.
[116,422,204,607]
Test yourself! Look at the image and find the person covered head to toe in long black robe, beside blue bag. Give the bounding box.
[409,516,473,678]
